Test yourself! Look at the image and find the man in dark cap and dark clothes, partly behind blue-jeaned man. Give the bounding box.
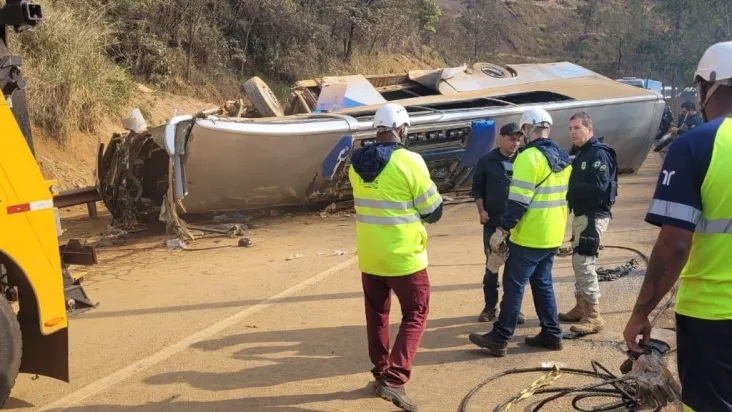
[472,123,524,323]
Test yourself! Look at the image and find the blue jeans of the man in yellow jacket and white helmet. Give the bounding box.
[492,241,562,342]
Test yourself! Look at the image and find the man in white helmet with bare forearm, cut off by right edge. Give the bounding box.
[623,42,732,411]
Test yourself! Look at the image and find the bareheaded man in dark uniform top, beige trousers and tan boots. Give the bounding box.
[559,112,618,334]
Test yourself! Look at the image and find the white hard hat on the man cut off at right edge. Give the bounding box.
[694,41,732,112]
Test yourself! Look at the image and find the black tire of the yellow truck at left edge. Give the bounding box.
[0,297,23,408]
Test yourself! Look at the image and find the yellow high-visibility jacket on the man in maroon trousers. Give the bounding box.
[348,148,442,276]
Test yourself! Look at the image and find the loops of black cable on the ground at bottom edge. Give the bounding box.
[458,361,658,412]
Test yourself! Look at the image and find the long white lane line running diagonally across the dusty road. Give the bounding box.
[38,256,358,411]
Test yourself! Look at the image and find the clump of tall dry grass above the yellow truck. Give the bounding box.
[13,2,134,142]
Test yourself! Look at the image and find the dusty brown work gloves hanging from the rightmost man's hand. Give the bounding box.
[620,339,681,410]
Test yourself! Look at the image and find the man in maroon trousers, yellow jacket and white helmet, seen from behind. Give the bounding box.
[348,103,442,411]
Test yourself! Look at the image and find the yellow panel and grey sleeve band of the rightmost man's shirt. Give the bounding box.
[664,119,732,320]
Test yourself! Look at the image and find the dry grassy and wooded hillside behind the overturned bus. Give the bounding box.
[7,0,732,142]
